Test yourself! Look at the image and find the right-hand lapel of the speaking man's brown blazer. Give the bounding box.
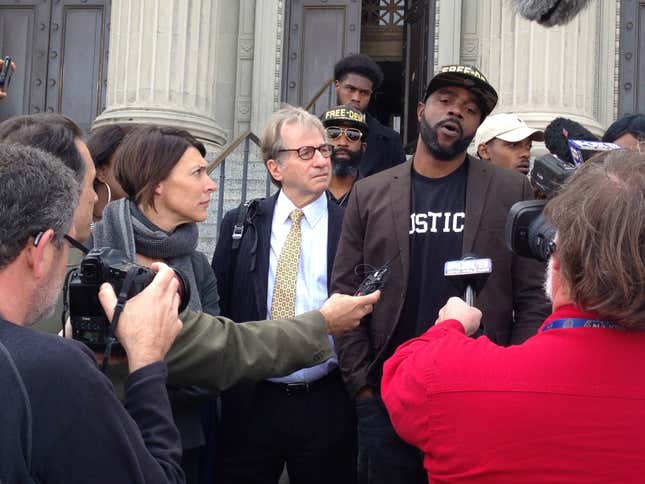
[462,156,492,255]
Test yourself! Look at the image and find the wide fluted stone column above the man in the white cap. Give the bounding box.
[461,0,616,134]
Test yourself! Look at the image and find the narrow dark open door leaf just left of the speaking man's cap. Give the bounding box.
[402,0,435,152]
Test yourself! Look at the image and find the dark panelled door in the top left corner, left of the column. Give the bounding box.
[0,0,110,130]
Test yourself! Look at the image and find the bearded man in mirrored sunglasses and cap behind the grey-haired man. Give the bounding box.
[321,105,369,208]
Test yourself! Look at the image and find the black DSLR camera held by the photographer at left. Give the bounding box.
[68,247,190,352]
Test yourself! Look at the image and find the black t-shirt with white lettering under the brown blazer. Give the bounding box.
[400,160,468,341]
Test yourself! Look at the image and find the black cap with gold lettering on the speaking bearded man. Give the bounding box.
[423,65,497,119]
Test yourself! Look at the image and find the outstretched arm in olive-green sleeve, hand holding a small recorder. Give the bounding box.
[166,291,380,393]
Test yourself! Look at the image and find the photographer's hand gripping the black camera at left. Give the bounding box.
[99,262,182,373]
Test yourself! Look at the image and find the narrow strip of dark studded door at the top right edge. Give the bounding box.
[618,0,645,116]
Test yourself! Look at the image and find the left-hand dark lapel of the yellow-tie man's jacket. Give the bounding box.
[253,192,279,319]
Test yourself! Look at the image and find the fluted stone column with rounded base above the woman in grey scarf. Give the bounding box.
[94,0,226,151]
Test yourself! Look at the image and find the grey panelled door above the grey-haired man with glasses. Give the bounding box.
[283,0,361,115]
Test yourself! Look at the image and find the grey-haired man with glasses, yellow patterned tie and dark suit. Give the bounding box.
[213,106,356,484]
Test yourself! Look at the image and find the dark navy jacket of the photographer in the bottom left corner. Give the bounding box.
[0,318,184,484]
